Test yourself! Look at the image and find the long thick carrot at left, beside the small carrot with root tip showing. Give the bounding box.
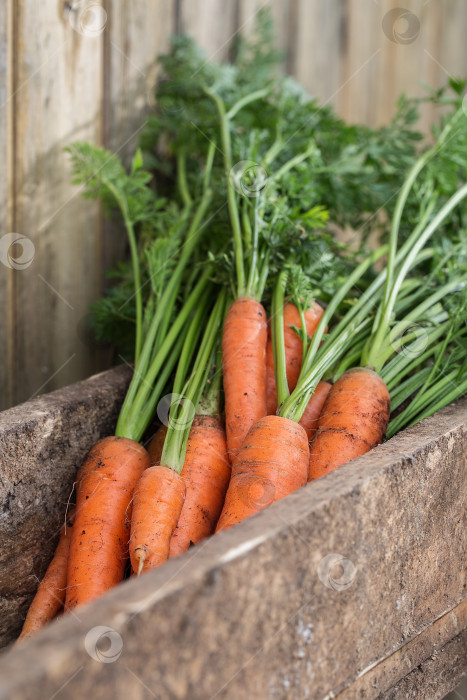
[65,437,149,610]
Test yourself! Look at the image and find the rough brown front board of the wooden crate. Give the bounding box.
[0,378,467,700]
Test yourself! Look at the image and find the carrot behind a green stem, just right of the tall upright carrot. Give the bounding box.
[266,302,323,416]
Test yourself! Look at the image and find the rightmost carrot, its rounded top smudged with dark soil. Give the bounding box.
[308,367,391,481]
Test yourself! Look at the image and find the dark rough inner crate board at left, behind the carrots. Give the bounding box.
[0,368,129,646]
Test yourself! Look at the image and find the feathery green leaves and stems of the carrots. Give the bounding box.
[69,12,467,439]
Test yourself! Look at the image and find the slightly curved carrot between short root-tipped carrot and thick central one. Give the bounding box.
[170,415,231,557]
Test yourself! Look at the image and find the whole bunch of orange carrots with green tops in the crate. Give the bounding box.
[14,20,467,639]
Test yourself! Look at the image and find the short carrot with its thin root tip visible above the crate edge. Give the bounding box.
[130,466,185,574]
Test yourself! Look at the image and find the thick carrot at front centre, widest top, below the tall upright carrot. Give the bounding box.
[216,416,309,532]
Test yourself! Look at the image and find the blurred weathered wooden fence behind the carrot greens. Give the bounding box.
[0,0,467,408]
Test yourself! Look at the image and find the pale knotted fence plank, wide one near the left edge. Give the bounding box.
[14,0,105,402]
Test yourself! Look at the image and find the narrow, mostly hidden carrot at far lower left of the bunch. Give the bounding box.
[17,509,75,642]
